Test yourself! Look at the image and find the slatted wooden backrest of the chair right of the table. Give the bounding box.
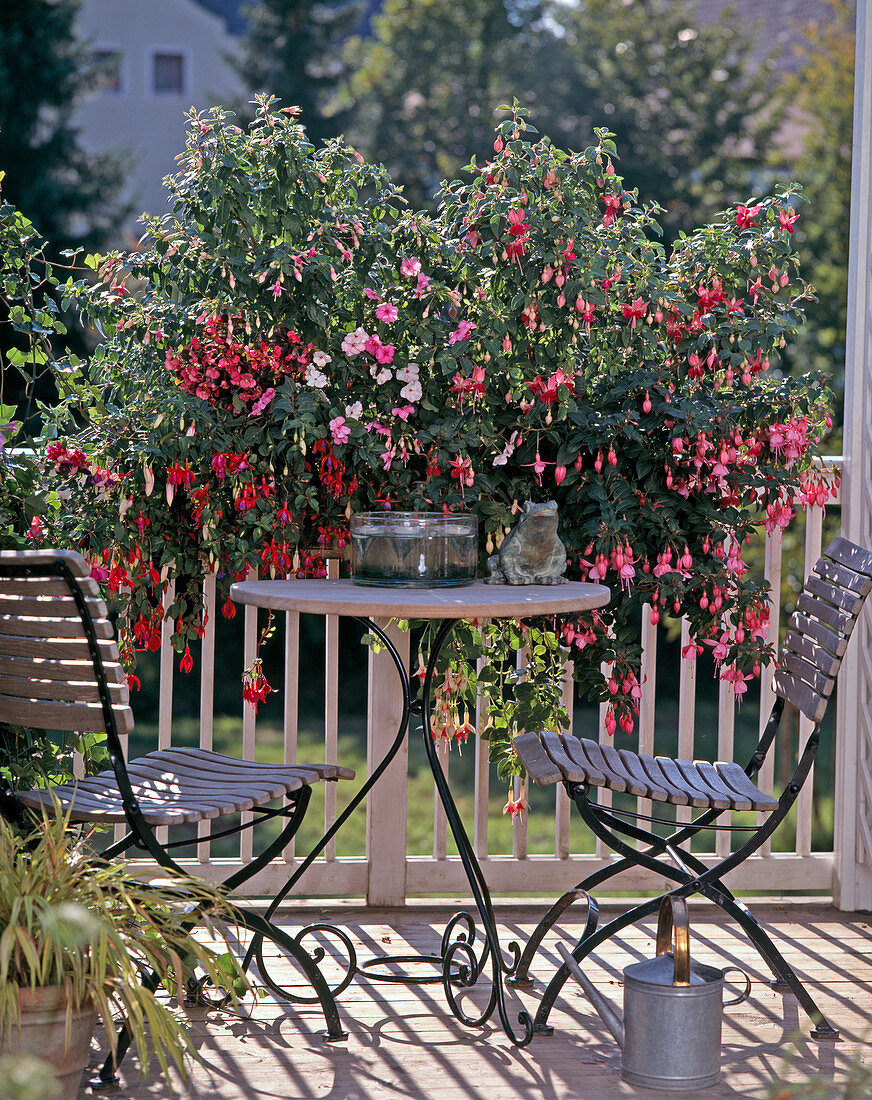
[773,538,872,724]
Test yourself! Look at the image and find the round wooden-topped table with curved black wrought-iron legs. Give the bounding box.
[230,580,610,1046]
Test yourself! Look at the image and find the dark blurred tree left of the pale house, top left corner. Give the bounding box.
[0,0,125,254]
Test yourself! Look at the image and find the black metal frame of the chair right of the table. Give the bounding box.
[509,539,872,1040]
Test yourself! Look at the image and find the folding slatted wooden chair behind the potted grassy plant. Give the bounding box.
[0,550,355,1082]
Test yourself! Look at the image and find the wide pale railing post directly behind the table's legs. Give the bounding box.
[366,619,409,905]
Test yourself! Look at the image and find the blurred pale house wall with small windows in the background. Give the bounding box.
[76,0,244,246]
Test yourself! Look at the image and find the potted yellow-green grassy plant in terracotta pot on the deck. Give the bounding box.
[0,815,242,1100]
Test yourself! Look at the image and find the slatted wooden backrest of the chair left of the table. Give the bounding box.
[0,550,133,736]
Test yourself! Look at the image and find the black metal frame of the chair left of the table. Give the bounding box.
[0,558,356,1087]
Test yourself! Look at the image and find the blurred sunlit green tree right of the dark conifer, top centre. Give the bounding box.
[344,0,545,207]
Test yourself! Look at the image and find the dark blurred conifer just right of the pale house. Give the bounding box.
[234,0,361,145]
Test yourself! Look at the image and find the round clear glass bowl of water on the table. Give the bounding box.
[351,512,478,589]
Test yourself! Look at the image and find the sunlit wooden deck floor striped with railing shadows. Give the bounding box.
[79,902,872,1100]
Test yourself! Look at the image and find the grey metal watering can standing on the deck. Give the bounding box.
[558,897,751,1092]
